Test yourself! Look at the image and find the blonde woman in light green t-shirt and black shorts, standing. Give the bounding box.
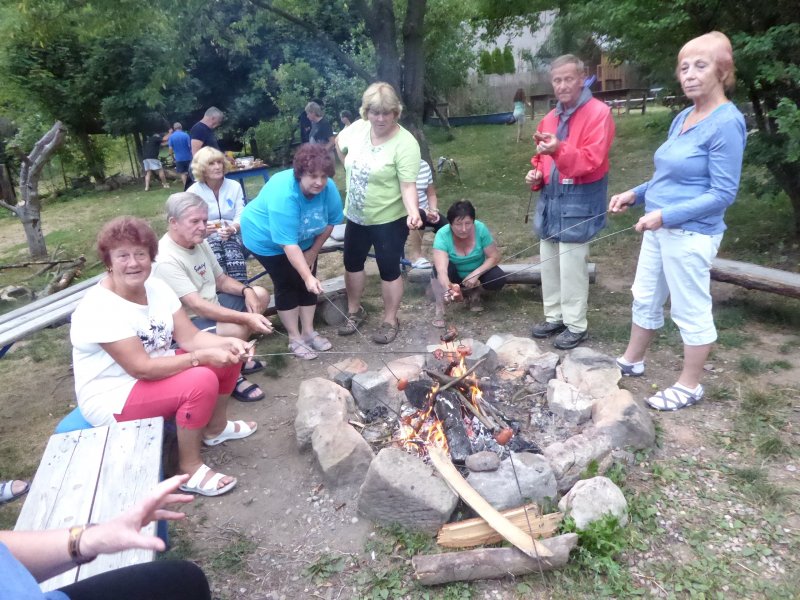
[336,82,422,344]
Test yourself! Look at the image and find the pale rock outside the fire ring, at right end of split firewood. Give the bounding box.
[558,477,628,529]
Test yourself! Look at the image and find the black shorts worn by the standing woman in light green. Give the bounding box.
[344,217,408,281]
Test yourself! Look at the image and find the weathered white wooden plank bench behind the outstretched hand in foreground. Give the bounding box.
[14,417,164,591]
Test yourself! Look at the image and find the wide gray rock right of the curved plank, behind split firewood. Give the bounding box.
[467,452,557,510]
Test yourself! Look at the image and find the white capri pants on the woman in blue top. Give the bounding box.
[631,227,722,346]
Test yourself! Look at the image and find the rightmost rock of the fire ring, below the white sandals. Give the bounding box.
[592,389,656,450]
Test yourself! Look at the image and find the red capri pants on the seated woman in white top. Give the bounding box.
[114,350,242,429]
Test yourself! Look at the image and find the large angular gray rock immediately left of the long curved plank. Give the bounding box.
[358,448,458,533]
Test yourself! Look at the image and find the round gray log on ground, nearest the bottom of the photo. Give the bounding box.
[411,533,578,585]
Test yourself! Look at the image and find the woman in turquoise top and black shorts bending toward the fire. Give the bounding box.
[241,144,344,360]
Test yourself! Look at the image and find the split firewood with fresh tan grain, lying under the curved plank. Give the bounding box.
[436,504,564,548]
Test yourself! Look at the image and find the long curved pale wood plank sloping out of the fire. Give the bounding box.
[427,444,552,558]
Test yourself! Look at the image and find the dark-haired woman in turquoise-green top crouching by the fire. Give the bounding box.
[431,200,506,327]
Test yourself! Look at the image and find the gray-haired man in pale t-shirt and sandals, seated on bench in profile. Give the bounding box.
[153,192,272,402]
